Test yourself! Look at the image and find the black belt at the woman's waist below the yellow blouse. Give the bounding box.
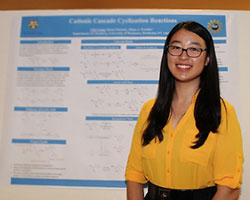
[144,182,216,200]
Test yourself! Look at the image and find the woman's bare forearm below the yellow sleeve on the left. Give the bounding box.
[127,181,144,200]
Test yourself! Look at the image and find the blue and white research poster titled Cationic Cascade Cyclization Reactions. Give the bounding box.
[0,10,238,187]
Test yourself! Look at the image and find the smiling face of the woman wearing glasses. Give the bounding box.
[167,29,209,84]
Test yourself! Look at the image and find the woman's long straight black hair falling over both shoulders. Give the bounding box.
[142,21,221,149]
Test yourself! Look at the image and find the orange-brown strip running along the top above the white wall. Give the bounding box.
[0,0,250,10]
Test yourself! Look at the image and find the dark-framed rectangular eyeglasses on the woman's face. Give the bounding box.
[167,46,207,58]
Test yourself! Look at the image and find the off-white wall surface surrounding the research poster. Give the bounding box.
[0,11,250,200]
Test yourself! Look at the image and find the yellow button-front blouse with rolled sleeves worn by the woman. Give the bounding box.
[125,94,243,189]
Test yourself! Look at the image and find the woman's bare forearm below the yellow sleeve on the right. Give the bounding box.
[212,185,240,200]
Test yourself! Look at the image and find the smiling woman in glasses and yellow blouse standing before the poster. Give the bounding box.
[126,21,243,200]
